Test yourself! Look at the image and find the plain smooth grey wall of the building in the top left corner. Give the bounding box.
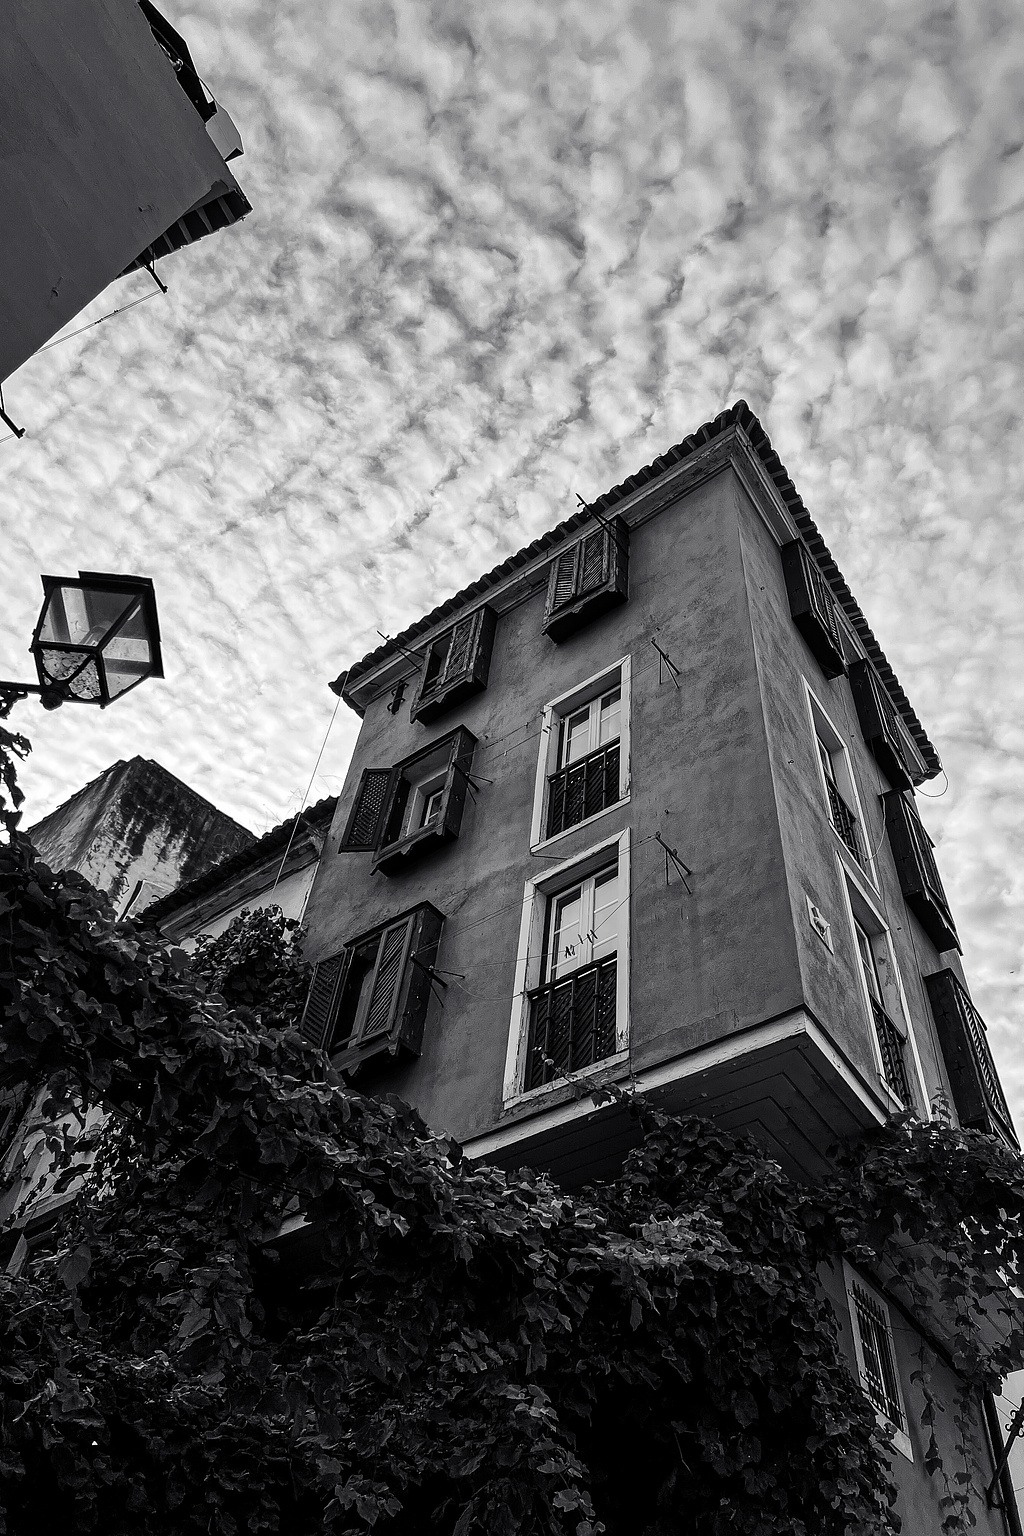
[0,0,244,379]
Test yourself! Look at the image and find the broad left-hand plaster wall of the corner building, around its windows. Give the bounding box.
[300,472,800,1138]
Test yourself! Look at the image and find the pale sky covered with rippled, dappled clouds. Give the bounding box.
[0,0,1024,1115]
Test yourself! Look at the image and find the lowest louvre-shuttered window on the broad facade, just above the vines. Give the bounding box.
[299,905,444,1071]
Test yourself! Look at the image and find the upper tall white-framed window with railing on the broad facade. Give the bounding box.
[530,657,629,846]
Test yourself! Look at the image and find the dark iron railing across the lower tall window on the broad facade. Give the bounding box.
[525,955,616,1087]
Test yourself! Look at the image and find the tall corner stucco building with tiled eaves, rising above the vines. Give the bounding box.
[302,402,1019,1536]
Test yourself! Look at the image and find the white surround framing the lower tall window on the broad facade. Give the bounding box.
[502,828,629,1106]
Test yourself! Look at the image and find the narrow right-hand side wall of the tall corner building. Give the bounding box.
[742,491,949,1107]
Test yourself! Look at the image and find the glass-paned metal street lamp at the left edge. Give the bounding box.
[0,571,164,719]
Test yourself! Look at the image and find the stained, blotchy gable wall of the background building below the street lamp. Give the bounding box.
[28,757,255,911]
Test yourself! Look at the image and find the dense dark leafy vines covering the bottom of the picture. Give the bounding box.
[0,734,1024,1536]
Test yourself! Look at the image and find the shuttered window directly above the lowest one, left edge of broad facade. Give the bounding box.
[341,727,476,874]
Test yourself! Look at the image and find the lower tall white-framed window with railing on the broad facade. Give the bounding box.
[505,833,629,1098]
